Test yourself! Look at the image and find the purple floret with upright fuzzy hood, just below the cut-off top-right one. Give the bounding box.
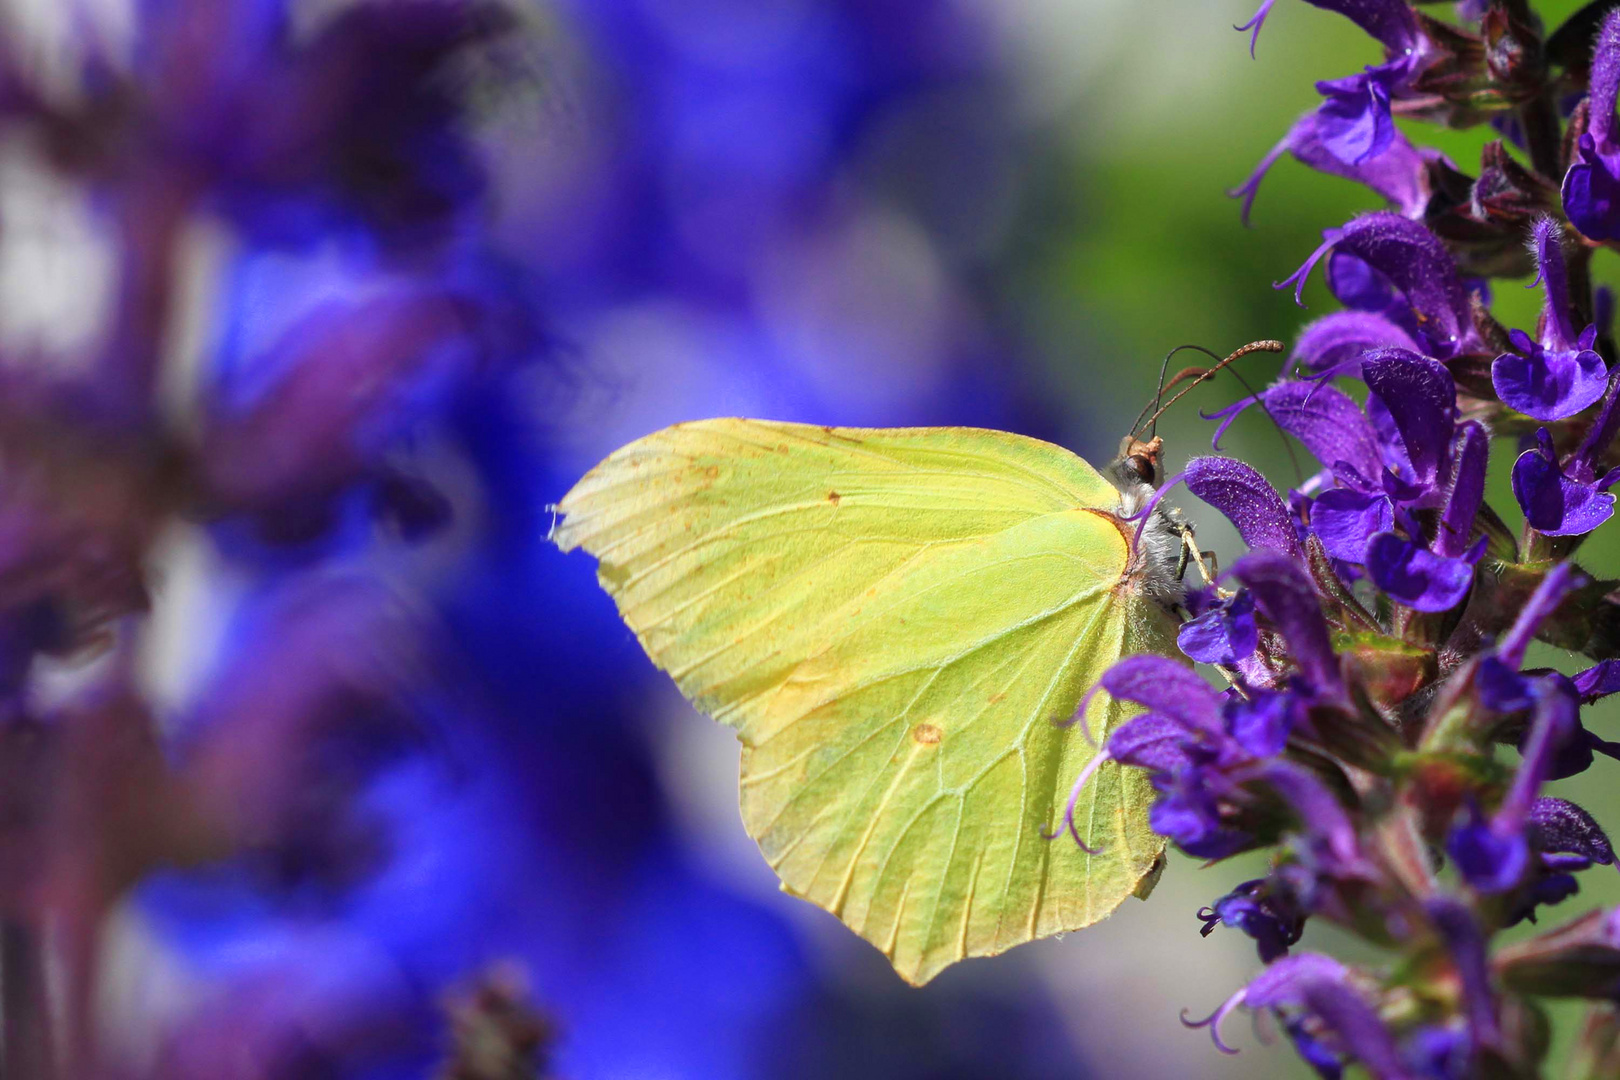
[1490,217,1609,421]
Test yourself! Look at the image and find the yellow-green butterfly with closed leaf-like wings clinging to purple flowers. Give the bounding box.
[554,409,1218,984]
